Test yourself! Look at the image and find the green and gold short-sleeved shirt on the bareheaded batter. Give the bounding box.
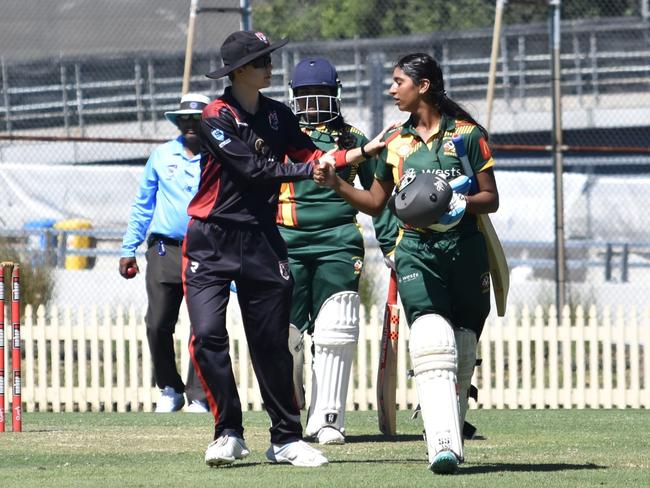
[375,117,494,234]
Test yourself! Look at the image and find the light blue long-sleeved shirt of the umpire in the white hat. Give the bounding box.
[121,136,201,257]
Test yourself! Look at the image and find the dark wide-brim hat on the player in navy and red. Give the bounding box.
[205,31,289,79]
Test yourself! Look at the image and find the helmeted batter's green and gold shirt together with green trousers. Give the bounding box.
[277,120,398,331]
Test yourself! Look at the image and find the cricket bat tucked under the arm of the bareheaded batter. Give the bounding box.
[451,134,510,317]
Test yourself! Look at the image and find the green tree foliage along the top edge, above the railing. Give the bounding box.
[253,0,639,41]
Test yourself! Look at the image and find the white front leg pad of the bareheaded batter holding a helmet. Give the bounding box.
[409,314,464,463]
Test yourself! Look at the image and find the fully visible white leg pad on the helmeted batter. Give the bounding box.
[305,291,360,435]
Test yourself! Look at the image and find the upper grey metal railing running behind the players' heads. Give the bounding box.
[0,19,650,134]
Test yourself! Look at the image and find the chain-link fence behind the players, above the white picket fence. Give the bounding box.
[0,0,650,305]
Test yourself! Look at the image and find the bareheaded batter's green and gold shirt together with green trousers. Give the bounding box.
[375,117,494,337]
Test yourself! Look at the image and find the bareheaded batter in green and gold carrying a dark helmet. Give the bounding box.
[315,53,499,473]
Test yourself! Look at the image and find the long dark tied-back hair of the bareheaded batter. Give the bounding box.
[395,53,488,140]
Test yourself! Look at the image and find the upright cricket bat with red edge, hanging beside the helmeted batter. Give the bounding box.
[377,271,399,435]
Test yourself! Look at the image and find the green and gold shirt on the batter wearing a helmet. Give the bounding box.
[276,124,397,254]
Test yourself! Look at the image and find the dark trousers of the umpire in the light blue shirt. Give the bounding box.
[145,239,205,403]
